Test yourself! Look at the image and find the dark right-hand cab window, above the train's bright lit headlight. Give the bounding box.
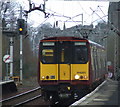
[74,46,88,64]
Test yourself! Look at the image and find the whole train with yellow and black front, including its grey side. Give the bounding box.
[38,37,106,100]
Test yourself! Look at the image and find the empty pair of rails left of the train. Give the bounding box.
[0,87,42,107]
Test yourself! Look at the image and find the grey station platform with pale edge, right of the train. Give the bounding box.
[70,79,120,107]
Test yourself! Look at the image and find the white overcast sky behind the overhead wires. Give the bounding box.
[16,0,109,29]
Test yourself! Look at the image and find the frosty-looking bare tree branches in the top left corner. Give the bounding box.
[1,0,19,30]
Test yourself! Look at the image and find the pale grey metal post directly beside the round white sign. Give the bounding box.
[10,37,13,77]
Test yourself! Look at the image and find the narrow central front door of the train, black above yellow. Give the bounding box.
[58,41,72,80]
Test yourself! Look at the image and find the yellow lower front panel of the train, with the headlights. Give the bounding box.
[40,63,89,80]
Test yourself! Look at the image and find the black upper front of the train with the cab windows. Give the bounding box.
[40,41,88,64]
